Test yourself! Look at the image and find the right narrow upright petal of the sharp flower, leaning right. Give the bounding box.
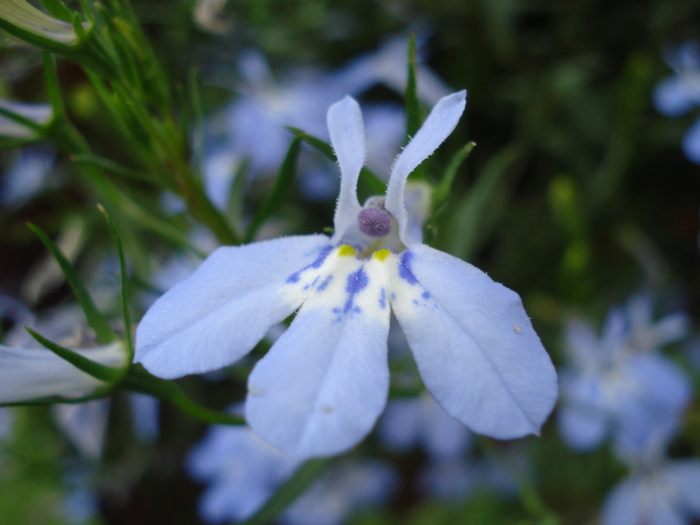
[385,90,467,246]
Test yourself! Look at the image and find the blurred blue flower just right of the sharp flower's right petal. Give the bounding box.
[559,297,691,451]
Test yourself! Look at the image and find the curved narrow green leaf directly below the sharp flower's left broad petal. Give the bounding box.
[120,365,245,425]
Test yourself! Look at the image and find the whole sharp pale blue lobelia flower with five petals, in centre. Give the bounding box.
[135,91,557,458]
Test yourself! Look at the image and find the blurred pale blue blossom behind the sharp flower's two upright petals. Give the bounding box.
[203,37,449,208]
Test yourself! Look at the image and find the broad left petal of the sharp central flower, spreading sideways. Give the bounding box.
[134,235,330,379]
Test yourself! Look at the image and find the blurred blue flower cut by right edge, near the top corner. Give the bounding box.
[653,42,700,164]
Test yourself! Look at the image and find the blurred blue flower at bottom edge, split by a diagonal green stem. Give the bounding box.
[187,412,396,525]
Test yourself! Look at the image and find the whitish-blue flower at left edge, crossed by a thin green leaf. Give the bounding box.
[0,342,126,403]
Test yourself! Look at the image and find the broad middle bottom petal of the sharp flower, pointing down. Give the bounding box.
[246,250,389,459]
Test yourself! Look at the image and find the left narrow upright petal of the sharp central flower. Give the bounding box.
[327,96,365,243]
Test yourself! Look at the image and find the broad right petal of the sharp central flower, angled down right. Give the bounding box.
[386,244,557,439]
